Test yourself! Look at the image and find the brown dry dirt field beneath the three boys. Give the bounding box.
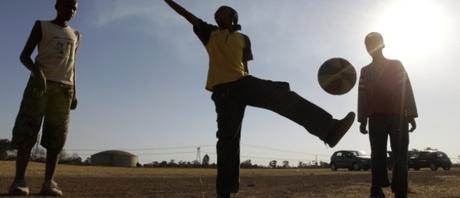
[0,161,460,198]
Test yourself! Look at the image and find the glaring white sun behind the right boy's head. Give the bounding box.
[375,0,450,59]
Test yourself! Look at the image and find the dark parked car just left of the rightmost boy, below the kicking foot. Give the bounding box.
[330,150,371,171]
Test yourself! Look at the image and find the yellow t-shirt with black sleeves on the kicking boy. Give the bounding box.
[193,21,253,91]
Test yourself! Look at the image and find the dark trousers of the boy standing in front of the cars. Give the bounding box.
[369,114,409,197]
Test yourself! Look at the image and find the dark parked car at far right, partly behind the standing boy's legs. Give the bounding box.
[388,151,452,171]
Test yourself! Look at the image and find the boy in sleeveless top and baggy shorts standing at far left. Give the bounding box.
[10,0,80,196]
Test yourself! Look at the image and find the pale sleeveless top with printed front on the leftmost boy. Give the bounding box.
[35,21,79,85]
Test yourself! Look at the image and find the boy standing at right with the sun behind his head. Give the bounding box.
[358,32,418,197]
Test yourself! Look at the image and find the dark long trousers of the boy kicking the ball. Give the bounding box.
[212,76,336,193]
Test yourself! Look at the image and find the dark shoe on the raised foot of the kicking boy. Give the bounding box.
[326,112,355,148]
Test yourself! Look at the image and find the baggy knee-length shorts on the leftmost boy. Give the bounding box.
[12,77,73,151]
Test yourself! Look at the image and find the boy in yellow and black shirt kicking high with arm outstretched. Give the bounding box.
[165,0,355,197]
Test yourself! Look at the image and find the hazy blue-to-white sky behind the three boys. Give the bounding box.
[0,0,460,165]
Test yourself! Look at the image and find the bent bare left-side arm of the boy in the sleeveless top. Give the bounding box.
[20,21,46,93]
